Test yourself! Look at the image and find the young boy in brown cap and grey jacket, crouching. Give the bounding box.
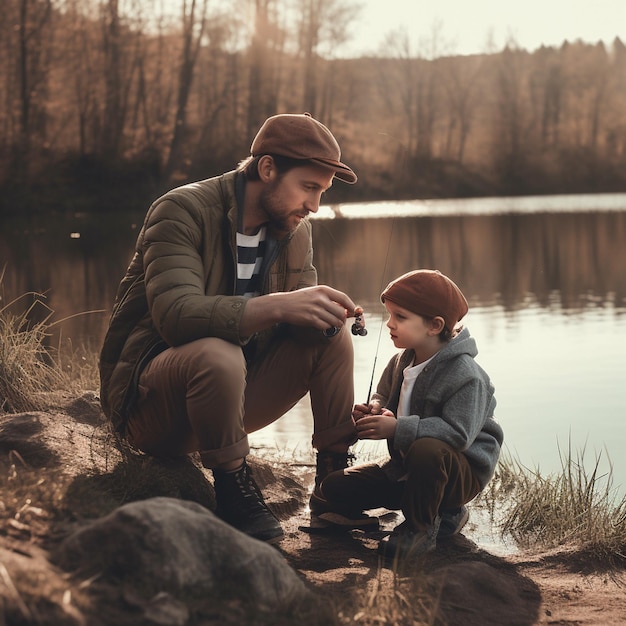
[317,270,503,559]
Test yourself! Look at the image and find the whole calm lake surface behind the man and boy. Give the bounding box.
[0,195,626,493]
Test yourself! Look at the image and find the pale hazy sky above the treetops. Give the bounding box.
[342,0,626,56]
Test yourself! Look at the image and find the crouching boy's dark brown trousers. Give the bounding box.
[322,438,481,531]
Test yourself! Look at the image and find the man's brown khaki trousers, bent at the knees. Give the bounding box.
[127,326,356,468]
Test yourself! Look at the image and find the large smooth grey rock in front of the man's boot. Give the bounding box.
[55,497,310,610]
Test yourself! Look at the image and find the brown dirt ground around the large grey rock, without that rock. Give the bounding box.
[0,394,626,626]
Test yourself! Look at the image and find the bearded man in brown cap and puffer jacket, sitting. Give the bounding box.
[100,114,357,541]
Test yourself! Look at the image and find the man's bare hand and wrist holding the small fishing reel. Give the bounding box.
[241,285,356,336]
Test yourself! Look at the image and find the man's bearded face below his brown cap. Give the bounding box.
[259,165,334,232]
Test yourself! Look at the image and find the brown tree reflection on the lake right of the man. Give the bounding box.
[315,212,626,310]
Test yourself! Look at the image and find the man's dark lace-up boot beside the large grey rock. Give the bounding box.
[213,459,284,542]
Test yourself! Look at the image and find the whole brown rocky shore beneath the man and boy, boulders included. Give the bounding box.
[0,393,626,626]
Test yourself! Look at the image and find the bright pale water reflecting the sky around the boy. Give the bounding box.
[253,304,626,480]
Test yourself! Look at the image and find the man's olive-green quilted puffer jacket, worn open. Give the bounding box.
[100,171,317,433]
